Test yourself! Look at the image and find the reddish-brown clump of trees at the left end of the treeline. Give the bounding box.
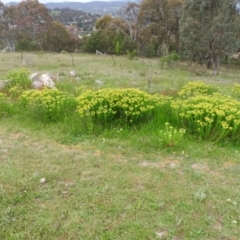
[0,0,79,52]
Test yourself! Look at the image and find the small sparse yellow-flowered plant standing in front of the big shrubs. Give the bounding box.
[159,122,186,147]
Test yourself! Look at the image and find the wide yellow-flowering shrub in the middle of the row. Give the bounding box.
[77,89,159,126]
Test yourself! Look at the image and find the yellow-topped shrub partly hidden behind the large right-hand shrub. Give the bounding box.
[178,82,218,99]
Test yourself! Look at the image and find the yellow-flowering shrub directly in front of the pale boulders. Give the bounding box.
[20,89,76,122]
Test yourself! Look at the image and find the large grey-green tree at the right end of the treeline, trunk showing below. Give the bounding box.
[180,0,240,74]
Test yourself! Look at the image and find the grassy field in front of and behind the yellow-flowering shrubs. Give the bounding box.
[0,53,240,240]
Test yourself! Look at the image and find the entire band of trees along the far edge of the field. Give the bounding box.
[0,0,240,69]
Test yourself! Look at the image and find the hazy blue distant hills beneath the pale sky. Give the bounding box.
[45,0,127,14]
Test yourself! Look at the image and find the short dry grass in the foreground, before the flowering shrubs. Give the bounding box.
[0,127,240,239]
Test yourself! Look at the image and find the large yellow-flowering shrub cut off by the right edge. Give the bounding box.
[172,93,240,141]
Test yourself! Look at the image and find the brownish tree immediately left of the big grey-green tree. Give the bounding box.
[138,0,182,54]
